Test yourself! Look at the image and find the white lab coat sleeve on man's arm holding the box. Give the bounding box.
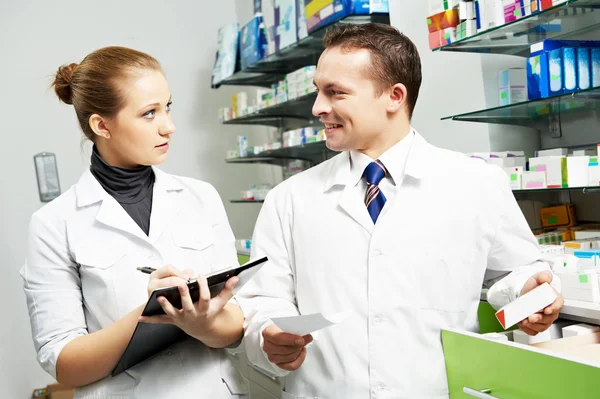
[484,166,560,309]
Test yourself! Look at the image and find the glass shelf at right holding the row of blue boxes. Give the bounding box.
[442,86,600,127]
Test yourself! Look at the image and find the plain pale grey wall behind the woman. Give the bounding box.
[0,0,260,399]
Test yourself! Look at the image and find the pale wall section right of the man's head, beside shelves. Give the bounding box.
[390,0,490,152]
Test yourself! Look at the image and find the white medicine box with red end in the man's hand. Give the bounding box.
[496,279,556,330]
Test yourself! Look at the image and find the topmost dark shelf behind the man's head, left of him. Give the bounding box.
[212,14,390,89]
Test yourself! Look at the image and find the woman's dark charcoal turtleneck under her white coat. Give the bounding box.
[90,146,154,235]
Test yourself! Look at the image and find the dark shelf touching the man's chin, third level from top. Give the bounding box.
[225,141,337,166]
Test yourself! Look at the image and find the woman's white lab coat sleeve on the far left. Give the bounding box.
[21,214,88,378]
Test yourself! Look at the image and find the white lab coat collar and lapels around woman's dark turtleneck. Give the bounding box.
[75,167,184,242]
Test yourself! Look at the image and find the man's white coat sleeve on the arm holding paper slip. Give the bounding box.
[236,189,299,377]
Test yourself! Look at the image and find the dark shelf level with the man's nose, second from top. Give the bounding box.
[223,93,317,130]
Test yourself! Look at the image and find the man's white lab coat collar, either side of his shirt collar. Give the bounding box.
[323,129,433,191]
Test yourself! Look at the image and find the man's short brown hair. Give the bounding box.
[323,23,421,118]
